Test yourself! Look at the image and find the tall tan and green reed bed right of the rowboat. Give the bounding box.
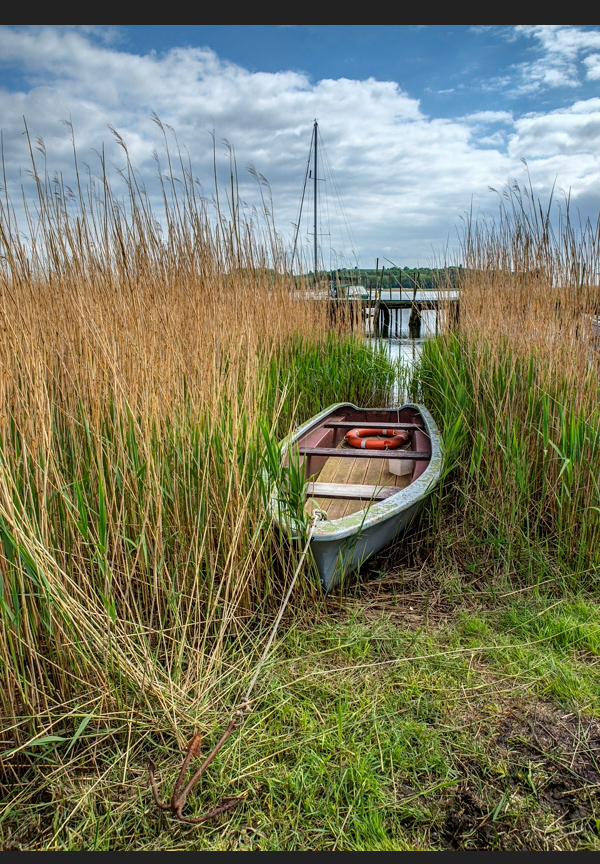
[419,184,600,588]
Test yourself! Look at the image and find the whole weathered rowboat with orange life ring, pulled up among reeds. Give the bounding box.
[271,402,442,591]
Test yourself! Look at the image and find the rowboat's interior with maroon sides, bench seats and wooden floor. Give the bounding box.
[294,406,431,520]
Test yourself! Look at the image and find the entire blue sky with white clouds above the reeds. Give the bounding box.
[0,24,600,267]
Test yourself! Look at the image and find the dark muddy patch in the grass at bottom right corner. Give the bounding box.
[434,703,600,851]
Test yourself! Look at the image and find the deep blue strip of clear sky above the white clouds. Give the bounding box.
[113,24,600,118]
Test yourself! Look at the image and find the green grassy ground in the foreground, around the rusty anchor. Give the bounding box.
[0,580,600,851]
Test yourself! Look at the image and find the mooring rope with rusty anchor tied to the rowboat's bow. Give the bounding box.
[148,510,326,825]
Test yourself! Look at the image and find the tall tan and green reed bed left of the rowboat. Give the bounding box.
[0,127,393,748]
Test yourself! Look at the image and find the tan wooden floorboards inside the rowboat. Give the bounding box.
[307,445,410,520]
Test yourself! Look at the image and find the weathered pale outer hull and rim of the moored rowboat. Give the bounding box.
[276,403,442,591]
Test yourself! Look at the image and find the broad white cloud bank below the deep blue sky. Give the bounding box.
[0,27,600,266]
